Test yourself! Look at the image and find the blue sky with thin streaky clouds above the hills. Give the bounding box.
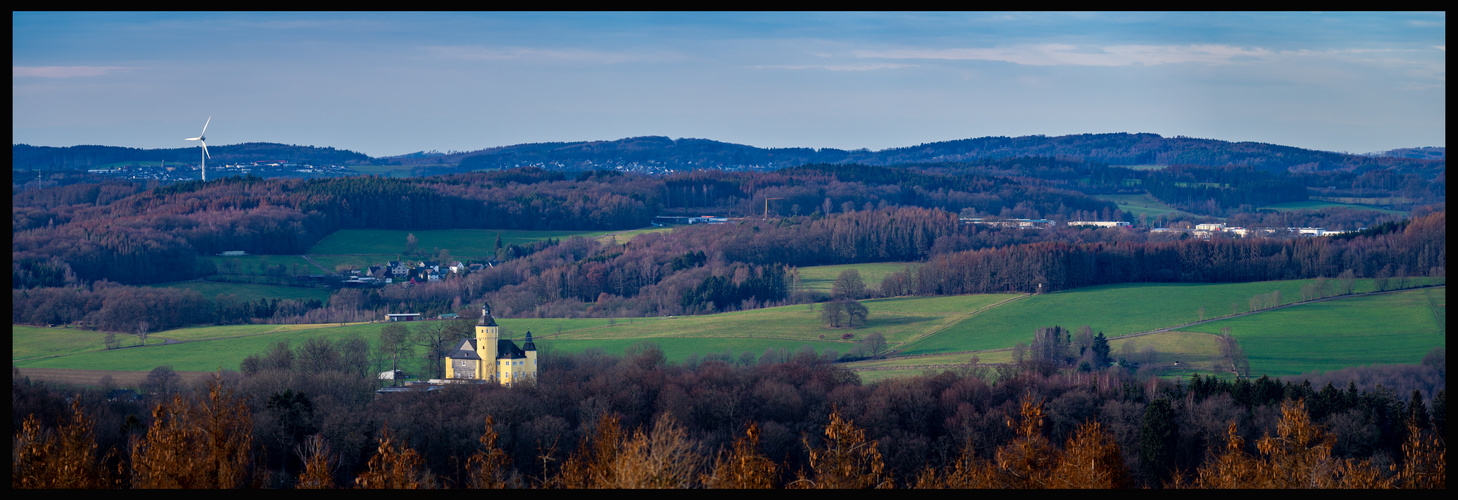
[10,12,1446,156]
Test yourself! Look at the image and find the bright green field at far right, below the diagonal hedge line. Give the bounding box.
[1188,287,1446,376]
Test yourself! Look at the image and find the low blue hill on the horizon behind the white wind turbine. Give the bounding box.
[10,143,370,171]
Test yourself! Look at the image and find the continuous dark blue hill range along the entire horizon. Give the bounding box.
[12,133,1445,178]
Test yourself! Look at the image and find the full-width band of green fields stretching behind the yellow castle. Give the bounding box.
[12,278,1445,380]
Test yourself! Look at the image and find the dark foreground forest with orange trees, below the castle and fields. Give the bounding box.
[12,337,1446,488]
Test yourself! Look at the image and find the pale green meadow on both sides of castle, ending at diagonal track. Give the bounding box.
[12,294,1015,370]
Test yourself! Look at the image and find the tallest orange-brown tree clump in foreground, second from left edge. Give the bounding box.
[131,376,258,488]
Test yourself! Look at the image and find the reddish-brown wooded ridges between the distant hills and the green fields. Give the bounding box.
[12,157,1446,331]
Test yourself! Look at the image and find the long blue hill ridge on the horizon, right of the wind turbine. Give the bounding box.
[391,133,1442,173]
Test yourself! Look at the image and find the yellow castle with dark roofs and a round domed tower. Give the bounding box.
[446,303,537,385]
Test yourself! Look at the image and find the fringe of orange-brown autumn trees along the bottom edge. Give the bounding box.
[12,359,1446,490]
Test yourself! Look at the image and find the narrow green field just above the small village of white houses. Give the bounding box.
[309,229,611,258]
